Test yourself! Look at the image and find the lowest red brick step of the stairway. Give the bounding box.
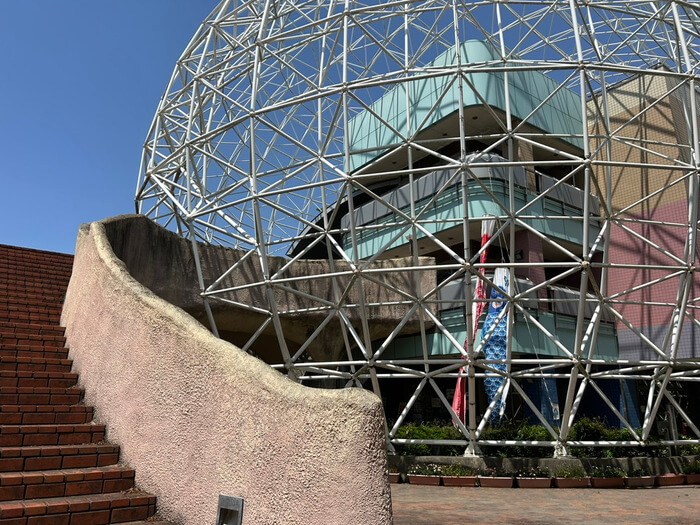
[0,490,156,525]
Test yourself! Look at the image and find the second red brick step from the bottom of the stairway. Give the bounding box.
[0,465,134,501]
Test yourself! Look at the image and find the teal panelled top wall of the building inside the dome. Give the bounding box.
[347,40,583,171]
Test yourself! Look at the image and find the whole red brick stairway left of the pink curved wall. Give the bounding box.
[0,245,170,525]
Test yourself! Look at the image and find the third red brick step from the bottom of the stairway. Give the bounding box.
[0,444,119,472]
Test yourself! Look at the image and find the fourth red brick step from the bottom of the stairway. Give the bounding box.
[0,423,105,447]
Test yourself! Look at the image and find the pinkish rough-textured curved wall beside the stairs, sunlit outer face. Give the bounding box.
[62,215,391,525]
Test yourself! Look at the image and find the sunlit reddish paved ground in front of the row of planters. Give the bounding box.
[391,484,700,525]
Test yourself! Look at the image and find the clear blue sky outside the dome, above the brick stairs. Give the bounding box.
[0,0,218,253]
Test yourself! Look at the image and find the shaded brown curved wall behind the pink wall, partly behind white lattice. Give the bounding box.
[103,215,437,363]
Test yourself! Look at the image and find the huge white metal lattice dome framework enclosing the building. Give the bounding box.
[136,0,700,455]
